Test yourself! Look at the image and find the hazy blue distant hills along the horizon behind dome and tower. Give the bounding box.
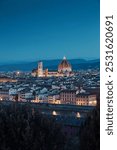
[0,59,100,71]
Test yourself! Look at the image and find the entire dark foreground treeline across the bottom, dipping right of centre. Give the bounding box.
[0,103,100,150]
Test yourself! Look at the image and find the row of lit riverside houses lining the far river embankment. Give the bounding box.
[0,88,97,106]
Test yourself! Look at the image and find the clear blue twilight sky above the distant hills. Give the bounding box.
[0,0,100,62]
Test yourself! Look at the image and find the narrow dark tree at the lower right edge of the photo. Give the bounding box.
[79,108,100,150]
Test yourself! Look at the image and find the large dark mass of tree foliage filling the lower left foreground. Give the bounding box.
[0,105,65,150]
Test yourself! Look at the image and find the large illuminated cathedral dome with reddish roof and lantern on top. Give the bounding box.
[58,57,72,73]
